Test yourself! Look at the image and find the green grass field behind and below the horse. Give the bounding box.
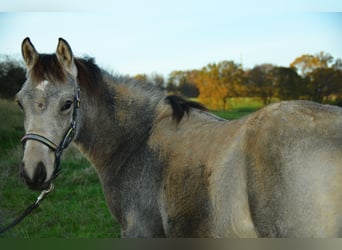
[0,99,259,239]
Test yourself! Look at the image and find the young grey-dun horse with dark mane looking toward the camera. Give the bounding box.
[16,38,342,238]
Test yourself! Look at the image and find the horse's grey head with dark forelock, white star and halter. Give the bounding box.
[16,38,79,190]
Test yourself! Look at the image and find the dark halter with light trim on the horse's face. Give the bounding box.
[21,86,80,179]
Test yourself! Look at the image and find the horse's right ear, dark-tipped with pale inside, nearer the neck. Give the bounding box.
[56,38,77,77]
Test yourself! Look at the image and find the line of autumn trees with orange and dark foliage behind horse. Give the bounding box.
[0,52,342,110]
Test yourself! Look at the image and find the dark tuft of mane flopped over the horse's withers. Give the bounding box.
[166,95,207,123]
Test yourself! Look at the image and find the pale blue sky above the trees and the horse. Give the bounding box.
[0,0,342,76]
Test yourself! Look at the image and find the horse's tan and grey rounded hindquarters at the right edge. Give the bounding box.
[245,101,342,237]
